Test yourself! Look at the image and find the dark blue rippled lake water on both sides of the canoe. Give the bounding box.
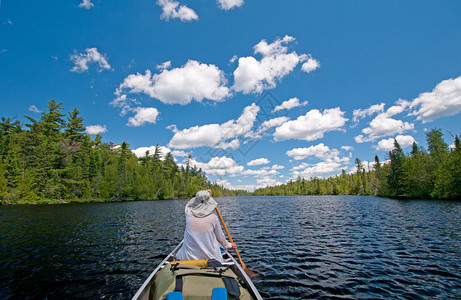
[0,196,461,299]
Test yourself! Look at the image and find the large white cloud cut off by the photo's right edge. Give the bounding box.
[410,76,461,123]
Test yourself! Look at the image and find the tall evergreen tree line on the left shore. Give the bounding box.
[0,100,245,204]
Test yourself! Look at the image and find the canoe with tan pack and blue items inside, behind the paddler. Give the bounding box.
[132,242,262,300]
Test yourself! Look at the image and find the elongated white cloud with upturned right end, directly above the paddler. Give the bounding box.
[168,103,259,149]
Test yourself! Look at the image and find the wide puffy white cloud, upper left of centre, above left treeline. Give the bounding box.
[114,60,230,105]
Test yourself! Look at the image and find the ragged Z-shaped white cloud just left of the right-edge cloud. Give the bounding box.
[354,99,414,143]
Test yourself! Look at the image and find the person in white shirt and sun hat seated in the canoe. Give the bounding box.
[176,190,237,262]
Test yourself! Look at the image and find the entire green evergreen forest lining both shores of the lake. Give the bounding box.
[0,100,461,204]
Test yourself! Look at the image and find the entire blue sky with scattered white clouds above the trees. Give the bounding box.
[0,0,461,190]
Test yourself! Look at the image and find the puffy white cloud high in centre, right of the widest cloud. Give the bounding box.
[232,35,309,94]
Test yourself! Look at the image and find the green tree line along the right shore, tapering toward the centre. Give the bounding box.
[253,129,461,198]
